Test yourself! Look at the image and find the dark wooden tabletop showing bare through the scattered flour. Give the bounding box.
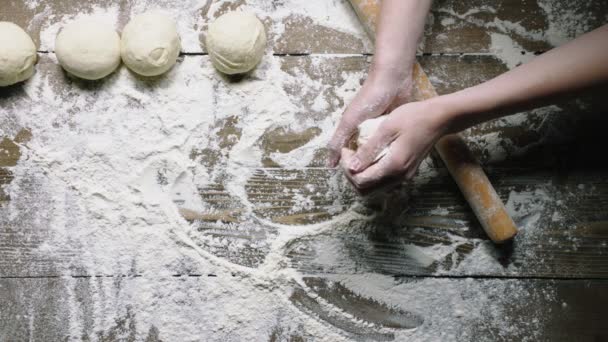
[0,0,608,341]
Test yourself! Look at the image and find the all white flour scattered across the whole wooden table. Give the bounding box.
[0,0,600,341]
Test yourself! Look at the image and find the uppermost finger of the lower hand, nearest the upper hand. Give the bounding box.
[349,123,396,173]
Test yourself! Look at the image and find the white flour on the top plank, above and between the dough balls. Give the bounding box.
[26,0,368,53]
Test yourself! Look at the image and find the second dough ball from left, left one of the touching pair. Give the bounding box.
[55,19,120,80]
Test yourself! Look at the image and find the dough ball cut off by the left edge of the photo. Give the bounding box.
[0,21,36,87]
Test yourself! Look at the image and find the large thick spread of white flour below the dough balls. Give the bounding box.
[0,46,360,341]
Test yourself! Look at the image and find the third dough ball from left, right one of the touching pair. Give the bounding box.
[121,11,181,76]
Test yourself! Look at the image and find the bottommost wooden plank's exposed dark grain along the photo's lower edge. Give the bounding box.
[0,277,608,342]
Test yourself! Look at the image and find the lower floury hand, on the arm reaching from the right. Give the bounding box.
[341,100,448,193]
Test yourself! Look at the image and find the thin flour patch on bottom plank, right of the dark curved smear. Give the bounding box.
[330,274,555,341]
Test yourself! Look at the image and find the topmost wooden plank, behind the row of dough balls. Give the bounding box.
[0,0,608,54]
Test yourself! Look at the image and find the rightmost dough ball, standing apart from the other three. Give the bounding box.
[206,12,266,75]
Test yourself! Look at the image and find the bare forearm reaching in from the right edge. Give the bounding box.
[437,25,608,132]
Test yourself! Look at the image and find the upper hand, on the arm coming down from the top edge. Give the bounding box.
[328,66,412,167]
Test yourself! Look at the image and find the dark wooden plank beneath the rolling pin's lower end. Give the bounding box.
[287,169,608,278]
